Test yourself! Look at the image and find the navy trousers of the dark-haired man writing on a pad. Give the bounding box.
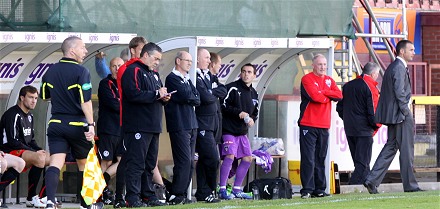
[124,132,159,205]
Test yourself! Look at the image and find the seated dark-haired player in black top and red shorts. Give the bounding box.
[0,86,49,207]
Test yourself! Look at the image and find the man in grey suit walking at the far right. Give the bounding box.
[364,40,422,194]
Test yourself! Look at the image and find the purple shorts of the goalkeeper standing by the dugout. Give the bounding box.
[220,134,252,159]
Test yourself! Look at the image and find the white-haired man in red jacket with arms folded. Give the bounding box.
[298,54,342,199]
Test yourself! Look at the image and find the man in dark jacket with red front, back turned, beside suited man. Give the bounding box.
[336,62,381,185]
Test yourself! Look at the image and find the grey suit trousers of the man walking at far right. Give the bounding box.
[366,115,419,191]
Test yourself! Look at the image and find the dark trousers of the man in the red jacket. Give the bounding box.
[299,126,329,193]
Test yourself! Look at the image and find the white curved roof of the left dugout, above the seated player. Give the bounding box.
[0,32,136,108]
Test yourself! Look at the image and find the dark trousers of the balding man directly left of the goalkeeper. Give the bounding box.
[195,130,220,200]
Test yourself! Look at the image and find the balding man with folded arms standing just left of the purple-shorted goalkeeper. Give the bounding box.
[195,49,226,203]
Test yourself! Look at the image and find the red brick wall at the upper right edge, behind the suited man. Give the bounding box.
[420,12,440,96]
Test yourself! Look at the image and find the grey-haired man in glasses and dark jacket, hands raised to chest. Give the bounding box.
[165,51,200,205]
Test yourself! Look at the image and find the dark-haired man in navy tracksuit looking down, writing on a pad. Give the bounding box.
[121,42,170,207]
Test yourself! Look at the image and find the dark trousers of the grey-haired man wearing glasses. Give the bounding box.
[169,129,197,196]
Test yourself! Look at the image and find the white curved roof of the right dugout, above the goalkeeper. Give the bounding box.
[158,36,334,135]
